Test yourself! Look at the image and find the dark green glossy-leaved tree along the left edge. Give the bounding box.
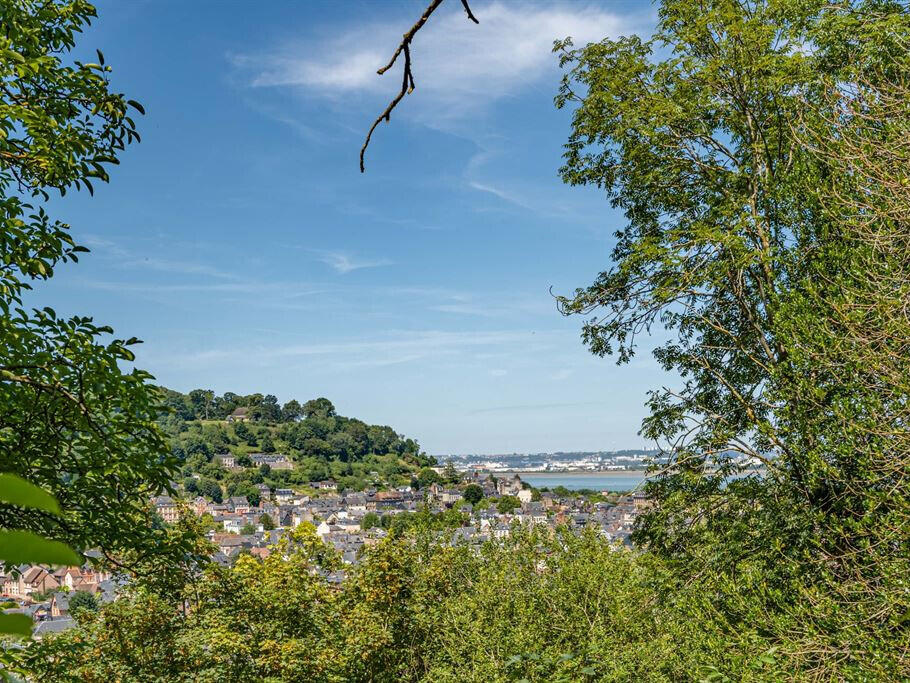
[0,0,190,568]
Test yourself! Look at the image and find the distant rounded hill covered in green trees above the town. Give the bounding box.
[160,389,436,496]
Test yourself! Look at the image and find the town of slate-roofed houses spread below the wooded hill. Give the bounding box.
[0,470,647,639]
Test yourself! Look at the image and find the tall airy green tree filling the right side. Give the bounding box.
[557,0,910,678]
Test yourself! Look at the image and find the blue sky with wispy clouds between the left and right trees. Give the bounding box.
[34,0,668,454]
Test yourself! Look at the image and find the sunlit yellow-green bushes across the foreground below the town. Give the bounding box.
[16,528,832,683]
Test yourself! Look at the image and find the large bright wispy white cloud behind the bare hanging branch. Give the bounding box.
[231,2,644,115]
